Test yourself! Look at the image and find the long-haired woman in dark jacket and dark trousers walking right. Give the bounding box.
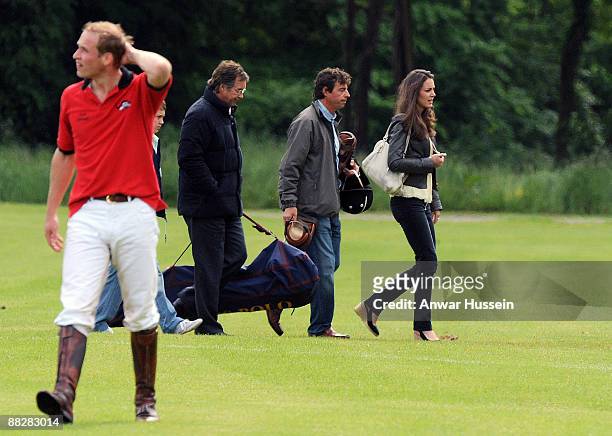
[355,70,455,341]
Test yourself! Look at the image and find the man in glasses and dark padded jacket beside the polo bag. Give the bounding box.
[178,61,249,335]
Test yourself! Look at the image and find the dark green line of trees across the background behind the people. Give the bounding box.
[0,0,612,168]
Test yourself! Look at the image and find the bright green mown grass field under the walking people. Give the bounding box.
[0,203,612,435]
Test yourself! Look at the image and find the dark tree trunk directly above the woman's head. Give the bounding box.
[393,0,414,87]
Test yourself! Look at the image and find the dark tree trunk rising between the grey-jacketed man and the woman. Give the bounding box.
[356,0,384,144]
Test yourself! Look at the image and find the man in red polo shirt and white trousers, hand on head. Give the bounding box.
[36,22,172,422]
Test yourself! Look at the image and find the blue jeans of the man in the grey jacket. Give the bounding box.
[306,215,340,335]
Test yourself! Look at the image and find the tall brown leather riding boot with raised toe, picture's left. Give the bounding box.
[36,326,87,424]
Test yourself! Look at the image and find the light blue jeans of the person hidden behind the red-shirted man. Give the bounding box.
[94,265,183,333]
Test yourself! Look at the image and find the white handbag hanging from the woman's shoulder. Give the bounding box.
[361,125,410,195]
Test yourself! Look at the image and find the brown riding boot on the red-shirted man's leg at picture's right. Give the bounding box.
[131,328,159,421]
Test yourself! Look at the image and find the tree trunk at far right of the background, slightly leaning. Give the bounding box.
[555,0,591,166]
